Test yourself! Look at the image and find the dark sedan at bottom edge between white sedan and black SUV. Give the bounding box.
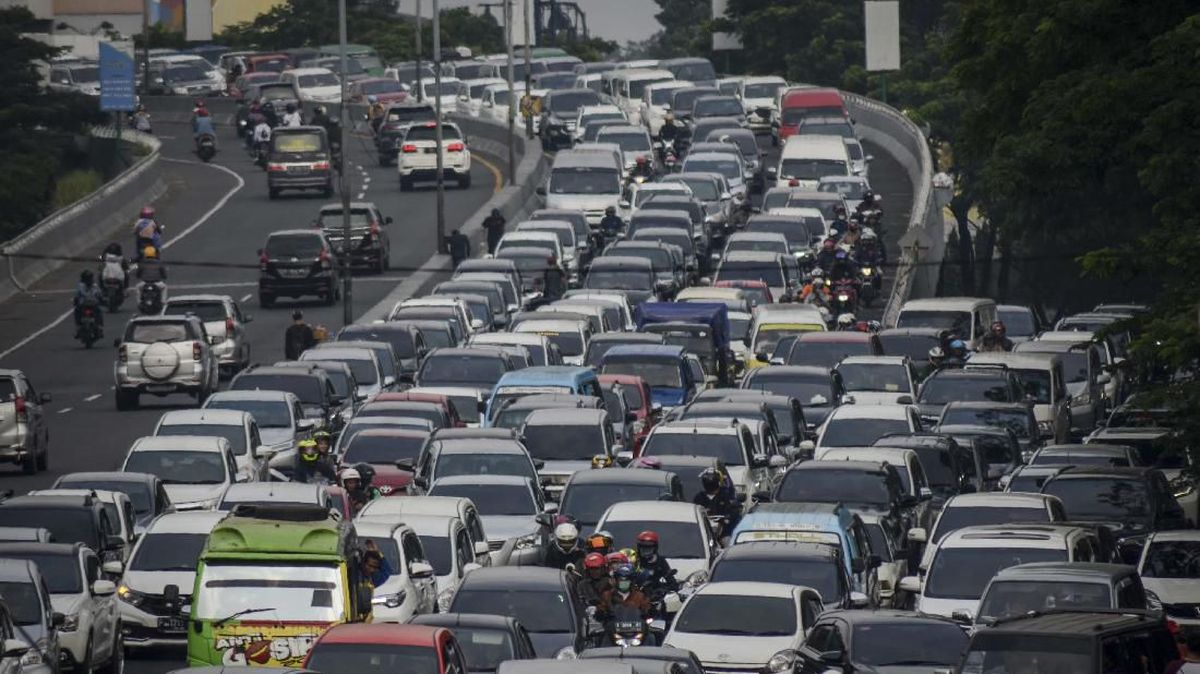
[793,610,970,674]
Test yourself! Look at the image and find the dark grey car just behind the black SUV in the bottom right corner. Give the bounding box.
[974,561,1152,626]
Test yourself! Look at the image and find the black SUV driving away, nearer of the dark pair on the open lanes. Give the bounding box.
[258,229,342,308]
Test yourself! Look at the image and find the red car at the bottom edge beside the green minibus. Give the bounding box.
[304,622,468,674]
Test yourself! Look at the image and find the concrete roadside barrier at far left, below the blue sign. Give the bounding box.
[0,127,166,301]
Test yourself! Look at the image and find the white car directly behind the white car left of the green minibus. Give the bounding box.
[121,435,237,512]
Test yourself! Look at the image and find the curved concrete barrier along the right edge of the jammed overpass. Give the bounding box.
[842,91,946,327]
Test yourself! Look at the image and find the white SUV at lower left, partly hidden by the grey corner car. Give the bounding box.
[0,539,125,674]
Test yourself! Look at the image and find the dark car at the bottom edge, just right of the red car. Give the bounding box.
[409,613,538,674]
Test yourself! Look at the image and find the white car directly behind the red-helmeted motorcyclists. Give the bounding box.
[595,501,720,582]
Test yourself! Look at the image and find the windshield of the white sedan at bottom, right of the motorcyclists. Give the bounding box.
[672,595,797,637]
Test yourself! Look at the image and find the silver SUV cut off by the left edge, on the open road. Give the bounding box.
[0,369,50,475]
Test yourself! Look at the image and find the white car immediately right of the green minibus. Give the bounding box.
[354,520,438,622]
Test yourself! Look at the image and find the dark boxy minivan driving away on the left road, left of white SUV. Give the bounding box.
[266,126,334,199]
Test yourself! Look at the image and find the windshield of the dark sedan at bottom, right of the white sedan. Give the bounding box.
[849,618,969,672]
